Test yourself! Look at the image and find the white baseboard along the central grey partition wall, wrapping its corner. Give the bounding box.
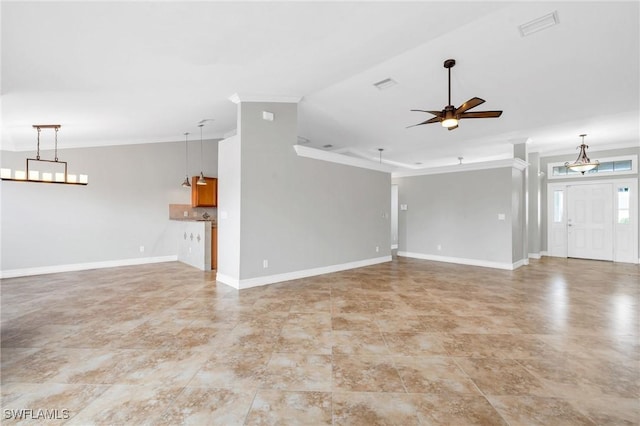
[216,256,392,290]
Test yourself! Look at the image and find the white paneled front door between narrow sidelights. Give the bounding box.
[567,183,613,260]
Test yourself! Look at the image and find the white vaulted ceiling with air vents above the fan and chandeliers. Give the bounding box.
[1,1,640,168]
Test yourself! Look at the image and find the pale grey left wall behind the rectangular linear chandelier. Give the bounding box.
[0,141,217,277]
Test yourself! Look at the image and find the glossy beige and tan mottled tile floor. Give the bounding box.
[1,258,640,425]
